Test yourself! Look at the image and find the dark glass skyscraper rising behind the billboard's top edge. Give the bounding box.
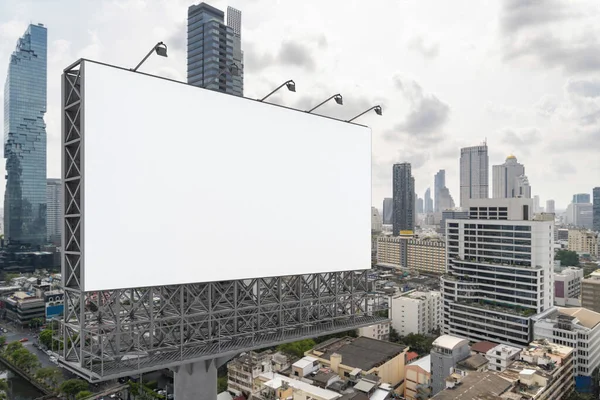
[187,3,244,96]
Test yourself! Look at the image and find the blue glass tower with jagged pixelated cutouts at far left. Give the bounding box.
[4,24,48,245]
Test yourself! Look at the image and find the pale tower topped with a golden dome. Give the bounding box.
[492,154,531,199]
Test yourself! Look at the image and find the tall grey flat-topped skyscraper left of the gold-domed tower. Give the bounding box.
[460,143,490,207]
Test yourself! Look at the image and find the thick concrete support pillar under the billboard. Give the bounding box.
[173,357,229,400]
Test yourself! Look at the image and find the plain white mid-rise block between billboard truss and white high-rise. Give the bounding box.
[391,291,442,336]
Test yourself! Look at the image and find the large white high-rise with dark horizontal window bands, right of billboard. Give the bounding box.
[441,198,554,346]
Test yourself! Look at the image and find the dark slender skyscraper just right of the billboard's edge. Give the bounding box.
[392,163,415,236]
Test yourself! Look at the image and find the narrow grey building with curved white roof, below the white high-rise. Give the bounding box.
[430,335,471,395]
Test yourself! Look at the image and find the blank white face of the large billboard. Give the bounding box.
[82,62,371,291]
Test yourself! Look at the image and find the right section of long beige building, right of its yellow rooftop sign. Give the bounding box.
[404,238,446,275]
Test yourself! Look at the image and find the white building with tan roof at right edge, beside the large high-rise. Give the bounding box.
[533,307,600,377]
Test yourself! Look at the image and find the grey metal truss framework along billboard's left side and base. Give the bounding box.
[56,60,387,381]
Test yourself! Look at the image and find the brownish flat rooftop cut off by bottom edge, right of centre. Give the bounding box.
[432,372,512,400]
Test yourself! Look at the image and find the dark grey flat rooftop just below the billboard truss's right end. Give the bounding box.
[311,336,407,372]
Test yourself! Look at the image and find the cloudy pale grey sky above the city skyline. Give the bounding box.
[0,0,600,208]
